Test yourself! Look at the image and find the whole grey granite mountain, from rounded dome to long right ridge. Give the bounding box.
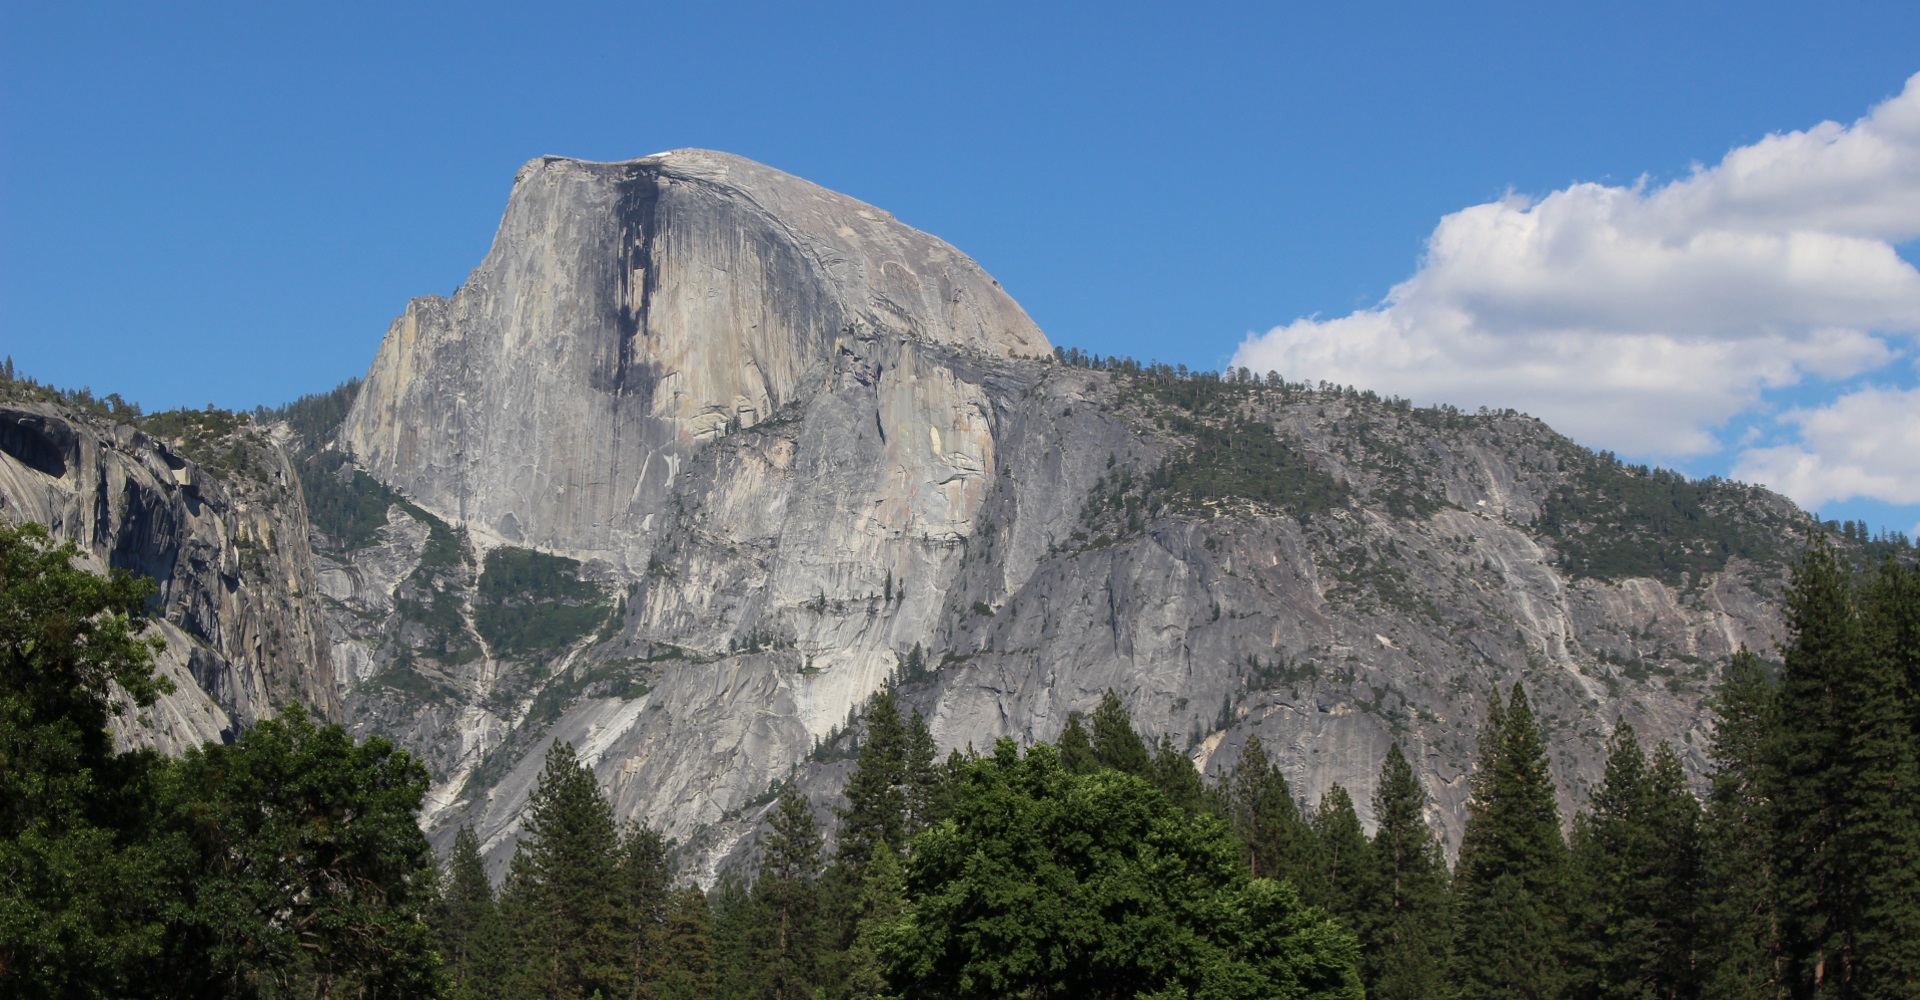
[319,150,1805,875]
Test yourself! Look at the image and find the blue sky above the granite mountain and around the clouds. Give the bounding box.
[0,0,1920,532]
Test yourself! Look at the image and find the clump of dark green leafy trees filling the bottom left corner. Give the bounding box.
[0,526,440,998]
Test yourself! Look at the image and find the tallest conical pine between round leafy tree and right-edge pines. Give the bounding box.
[1452,683,1567,1000]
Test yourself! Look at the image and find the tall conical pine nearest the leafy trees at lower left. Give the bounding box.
[501,741,628,1000]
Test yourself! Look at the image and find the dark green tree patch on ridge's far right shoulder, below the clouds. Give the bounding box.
[1540,451,1786,585]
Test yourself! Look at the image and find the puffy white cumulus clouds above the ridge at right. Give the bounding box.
[1233,75,1920,487]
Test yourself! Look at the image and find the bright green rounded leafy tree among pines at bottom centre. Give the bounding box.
[877,739,1361,1000]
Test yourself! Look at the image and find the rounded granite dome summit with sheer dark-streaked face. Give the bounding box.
[342,150,1050,568]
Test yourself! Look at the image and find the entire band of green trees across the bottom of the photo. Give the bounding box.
[0,514,1920,1000]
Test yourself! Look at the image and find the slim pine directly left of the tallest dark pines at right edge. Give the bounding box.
[1699,647,1780,1000]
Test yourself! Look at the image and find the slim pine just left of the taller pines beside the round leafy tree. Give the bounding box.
[753,783,820,1000]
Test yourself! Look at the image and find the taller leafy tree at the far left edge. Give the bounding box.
[0,524,171,996]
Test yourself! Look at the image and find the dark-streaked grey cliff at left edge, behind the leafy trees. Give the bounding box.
[0,401,340,750]
